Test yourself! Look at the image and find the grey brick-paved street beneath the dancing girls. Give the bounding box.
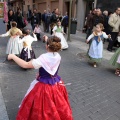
[0,20,120,120]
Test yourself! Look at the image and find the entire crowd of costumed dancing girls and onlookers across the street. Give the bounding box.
[0,5,120,120]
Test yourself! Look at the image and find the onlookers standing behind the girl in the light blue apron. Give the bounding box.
[85,7,120,52]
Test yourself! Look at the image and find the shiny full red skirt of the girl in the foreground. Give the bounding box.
[16,82,73,120]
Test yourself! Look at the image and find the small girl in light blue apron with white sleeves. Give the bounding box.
[86,23,110,67]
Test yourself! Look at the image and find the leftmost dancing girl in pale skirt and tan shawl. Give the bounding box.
[0,21,23,55]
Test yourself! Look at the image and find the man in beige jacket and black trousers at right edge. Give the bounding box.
[107,7,120,52]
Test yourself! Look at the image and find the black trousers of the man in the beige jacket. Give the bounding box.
[108,32,118,50]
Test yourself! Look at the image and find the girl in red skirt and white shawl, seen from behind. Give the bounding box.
[8,36,73,120]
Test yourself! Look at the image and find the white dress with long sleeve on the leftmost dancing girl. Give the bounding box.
[1,31,23,55]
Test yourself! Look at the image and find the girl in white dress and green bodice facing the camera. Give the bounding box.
[53,20,68,49]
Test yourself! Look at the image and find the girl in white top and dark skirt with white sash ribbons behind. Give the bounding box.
[18,28,37,62]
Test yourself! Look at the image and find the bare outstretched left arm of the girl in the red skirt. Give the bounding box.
[8,54,34,68]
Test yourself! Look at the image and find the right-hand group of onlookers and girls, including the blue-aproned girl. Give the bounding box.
[85,7,120,76]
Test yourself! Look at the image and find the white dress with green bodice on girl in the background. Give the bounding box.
[53,26,68,49]
